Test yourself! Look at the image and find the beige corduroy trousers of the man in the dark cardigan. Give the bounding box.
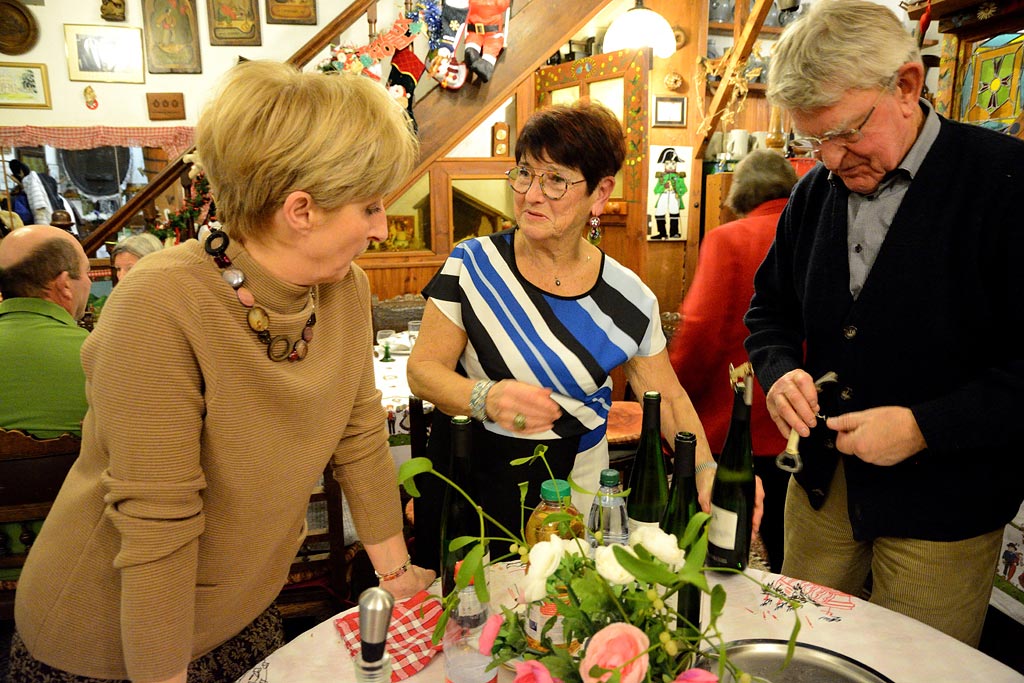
[782,461,1002,647]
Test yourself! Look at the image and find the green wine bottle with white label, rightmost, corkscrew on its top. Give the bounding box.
[708,375,754,569]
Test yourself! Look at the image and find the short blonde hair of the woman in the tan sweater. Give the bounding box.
[196,61,419,240]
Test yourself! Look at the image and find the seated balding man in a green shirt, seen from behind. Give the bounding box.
[0,225,91,438]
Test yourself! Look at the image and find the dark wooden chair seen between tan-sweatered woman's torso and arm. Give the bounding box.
[276,464,361,622]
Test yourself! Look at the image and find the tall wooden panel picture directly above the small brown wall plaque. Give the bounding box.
[142,0,203,74]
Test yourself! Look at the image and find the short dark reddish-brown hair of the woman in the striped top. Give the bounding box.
[515,100,626,193]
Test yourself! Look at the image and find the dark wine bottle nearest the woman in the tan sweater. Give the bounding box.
[440,415,480,595]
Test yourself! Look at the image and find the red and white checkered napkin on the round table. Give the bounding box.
[334,591,443,683]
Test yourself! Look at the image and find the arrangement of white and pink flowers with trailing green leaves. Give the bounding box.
[398,445,800,683]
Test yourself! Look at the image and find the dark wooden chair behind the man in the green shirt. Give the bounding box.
[0,429,82,620]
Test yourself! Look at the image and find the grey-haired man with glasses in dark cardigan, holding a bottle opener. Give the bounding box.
[744,0,1024,645]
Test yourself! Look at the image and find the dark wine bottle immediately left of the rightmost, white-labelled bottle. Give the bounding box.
[662,432,700,638]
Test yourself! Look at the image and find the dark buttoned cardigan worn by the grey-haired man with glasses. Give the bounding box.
[744,119,1024,541]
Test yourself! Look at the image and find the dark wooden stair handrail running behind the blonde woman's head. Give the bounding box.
[82,0,377,254]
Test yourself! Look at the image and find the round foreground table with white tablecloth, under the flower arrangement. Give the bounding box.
[237,562,1024,683]
